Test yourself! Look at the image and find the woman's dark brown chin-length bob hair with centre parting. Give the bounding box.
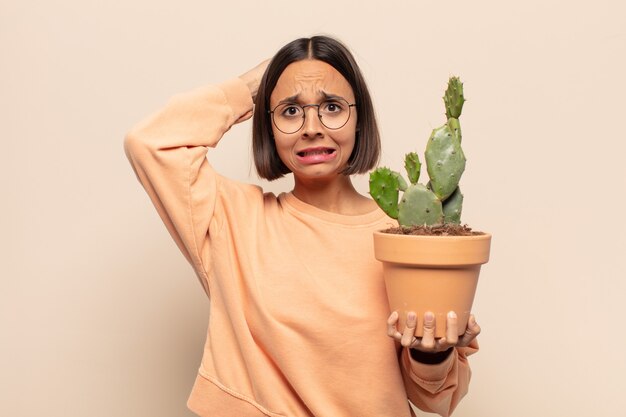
[252,36,380,181]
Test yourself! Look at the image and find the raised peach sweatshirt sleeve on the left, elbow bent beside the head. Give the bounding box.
[124,78,252,295]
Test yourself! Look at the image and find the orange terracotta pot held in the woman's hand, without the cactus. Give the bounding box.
[374,232,491,337]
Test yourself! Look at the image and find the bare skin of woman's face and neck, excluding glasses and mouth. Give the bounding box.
[270,60,376,215]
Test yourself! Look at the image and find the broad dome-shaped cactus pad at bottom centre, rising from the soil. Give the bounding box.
[398,184,443,226]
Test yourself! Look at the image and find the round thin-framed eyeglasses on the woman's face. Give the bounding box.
[269,98,356,134]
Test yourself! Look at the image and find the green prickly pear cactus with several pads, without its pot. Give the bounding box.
[369,77,465,227]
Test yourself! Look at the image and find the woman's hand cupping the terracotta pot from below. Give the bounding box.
[387,311,480,353]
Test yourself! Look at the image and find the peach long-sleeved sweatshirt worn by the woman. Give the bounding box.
[124,79,476,417]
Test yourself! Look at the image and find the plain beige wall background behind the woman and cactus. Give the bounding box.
[0,0,626,417]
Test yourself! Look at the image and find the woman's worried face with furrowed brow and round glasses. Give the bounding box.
[270,60,357,179]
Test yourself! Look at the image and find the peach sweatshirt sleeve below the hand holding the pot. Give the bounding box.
[400,340,478,417]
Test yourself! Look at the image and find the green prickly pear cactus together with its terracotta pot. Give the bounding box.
[369,77,491,337]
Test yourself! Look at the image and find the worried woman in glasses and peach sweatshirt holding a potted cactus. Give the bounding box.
[125,36,479,417]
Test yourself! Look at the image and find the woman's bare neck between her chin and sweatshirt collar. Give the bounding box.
[293,175,374,215]
